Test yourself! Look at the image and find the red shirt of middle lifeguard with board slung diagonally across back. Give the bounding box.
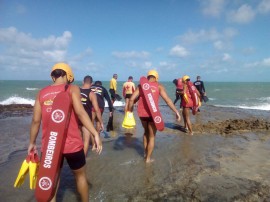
[137,82,159,117]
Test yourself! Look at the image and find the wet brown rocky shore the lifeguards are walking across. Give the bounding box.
[0,106,270,201]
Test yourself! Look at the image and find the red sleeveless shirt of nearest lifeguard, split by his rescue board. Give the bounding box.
[39,84,83,153]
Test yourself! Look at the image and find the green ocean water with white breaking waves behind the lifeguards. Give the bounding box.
[0,80,270,110]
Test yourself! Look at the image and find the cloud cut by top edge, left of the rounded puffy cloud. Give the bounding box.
[201,0,225,17]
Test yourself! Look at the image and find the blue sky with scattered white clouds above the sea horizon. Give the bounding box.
[0,0,270,82]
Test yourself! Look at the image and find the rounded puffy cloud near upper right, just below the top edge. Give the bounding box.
[227,4,256,24]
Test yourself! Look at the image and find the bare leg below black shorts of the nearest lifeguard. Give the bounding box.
[73,166,89,202]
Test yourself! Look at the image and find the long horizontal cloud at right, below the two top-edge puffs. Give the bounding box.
[179,28,238,44]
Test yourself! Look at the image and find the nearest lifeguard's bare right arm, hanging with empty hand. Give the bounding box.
[70,85,102,154]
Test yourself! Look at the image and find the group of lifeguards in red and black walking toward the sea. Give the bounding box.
[25,63,205,201]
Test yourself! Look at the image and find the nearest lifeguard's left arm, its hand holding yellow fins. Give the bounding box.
[28,93,42,154]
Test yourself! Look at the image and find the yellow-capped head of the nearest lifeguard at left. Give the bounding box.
[51,62,74,83]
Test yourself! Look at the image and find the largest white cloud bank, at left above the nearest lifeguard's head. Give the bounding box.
[0,27,72,71]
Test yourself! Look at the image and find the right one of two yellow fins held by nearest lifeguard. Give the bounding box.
[29,152,39,189]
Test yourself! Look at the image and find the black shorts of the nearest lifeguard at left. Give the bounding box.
[61,149,86,170]
